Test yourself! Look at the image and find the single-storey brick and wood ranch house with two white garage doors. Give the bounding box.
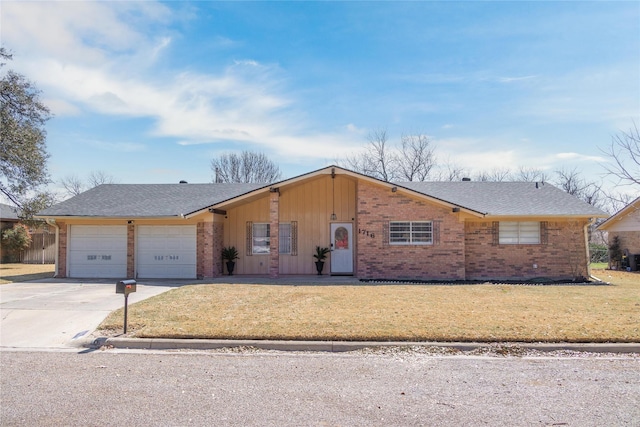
[38,166,607,280]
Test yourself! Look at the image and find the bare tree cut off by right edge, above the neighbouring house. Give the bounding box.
[603,122,640,185]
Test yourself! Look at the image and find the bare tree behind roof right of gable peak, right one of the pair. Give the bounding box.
[398,135,436,181]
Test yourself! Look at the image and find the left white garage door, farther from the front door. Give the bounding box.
[68,225,127,278]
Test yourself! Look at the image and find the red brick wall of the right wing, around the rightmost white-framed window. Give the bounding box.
[465,221,588,280]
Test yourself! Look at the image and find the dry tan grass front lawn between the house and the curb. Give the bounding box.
[99,270,640,342]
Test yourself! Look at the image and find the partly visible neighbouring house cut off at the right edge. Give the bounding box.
[598,197,640,270]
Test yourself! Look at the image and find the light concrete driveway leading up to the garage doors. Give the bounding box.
[0,279,182,348]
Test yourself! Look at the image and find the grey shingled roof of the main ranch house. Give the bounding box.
[38,166,608,218]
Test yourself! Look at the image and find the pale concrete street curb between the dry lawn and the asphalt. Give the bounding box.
[100,337,640,353]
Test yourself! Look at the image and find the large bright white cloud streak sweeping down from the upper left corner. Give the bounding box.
[2,2,361,164]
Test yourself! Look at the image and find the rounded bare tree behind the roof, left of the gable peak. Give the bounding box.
[211,151,282,184]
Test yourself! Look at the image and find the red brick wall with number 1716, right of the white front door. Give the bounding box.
[354,181,465,280]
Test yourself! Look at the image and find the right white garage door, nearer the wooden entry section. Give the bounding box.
[136,225,197,279]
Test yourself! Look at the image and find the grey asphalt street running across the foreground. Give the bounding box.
[0,350,640,426]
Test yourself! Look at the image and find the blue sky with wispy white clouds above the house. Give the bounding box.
[0,0,640,196]
